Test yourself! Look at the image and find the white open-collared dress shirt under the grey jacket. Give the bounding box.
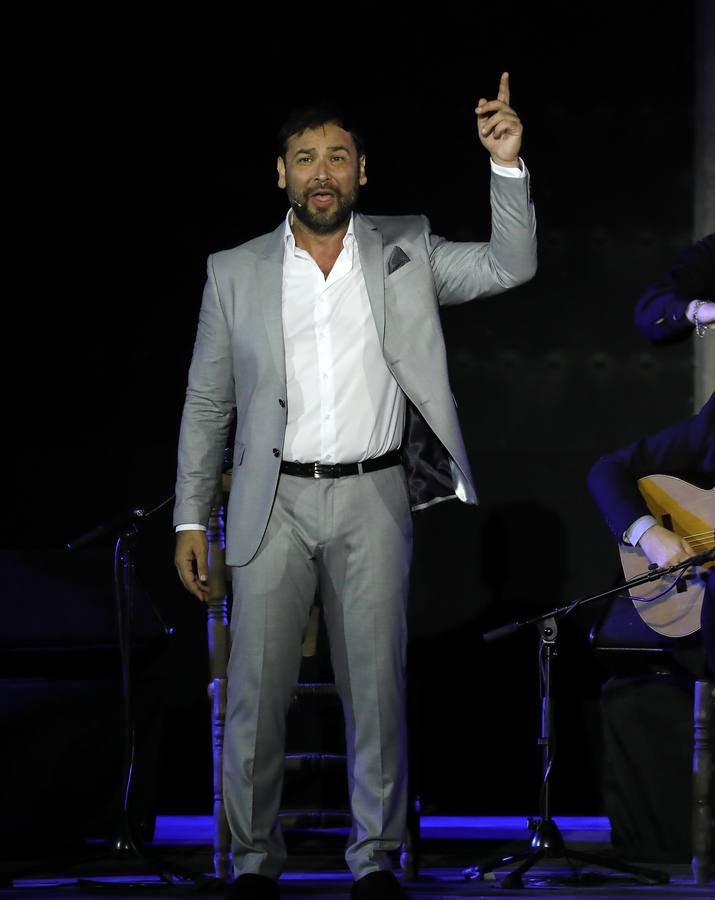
[283,212,405,463]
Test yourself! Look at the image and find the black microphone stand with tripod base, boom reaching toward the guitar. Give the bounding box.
[462,549,715,888]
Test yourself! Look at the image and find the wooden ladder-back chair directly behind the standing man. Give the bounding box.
[201,472,419,881]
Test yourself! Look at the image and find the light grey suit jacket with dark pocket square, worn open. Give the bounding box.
[174,174,536,565]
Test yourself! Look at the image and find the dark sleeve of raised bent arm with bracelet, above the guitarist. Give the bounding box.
[633,234,715,344]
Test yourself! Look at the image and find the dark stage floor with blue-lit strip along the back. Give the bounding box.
[0,816,715,900]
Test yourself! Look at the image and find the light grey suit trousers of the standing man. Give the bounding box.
[224,466,412,878]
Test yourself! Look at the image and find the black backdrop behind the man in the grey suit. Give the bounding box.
[0,2,695,828]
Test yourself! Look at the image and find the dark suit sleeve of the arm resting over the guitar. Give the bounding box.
[588,394,715,541]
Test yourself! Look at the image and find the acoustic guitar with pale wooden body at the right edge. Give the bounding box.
[618,475,715,637]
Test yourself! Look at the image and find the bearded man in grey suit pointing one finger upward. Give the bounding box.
[174,73,536,900]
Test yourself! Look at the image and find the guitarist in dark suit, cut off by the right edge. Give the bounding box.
[588,393,715,679]
